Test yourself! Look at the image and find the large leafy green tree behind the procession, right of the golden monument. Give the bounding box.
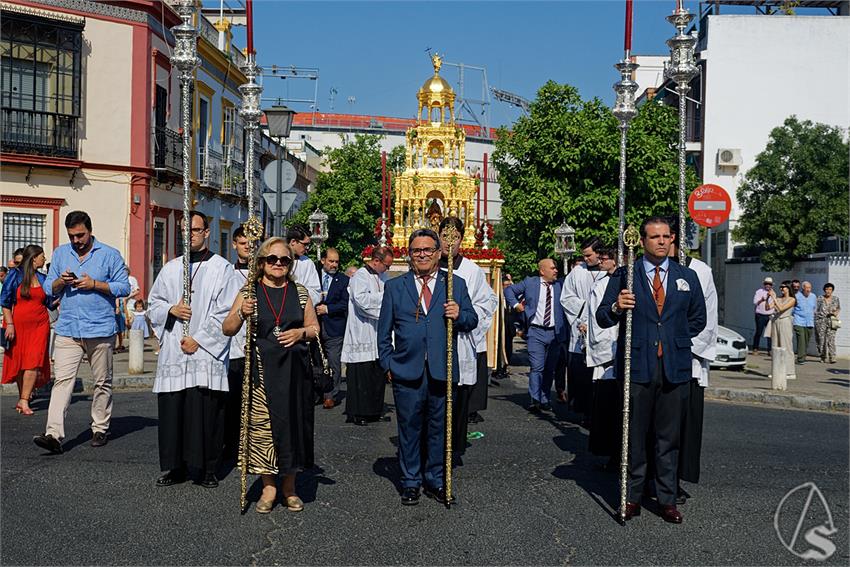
[493,81,697,274]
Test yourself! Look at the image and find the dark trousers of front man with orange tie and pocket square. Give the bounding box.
[629,360,690,506]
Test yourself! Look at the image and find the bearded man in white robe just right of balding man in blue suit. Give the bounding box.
[561,236,606,424]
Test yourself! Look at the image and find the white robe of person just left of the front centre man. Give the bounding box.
[341,268,384,363]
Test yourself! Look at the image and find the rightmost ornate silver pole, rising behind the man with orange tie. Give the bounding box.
[664,0,699,266]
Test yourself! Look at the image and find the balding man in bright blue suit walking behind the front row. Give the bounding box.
[504,259,567,412]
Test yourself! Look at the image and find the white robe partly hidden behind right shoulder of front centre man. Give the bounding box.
[444,258,499,386]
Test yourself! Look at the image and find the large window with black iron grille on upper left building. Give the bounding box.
[0,12,83,158]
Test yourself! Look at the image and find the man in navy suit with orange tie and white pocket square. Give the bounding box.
[596,217,706,524]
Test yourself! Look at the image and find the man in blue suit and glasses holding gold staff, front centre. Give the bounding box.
[378,229,478,506]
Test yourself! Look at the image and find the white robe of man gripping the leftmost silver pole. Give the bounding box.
[148,254,241,393]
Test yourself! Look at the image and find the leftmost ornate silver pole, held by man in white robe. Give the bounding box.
[171,0,201,336]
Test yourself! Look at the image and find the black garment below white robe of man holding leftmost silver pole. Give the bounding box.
[157,388,227,473]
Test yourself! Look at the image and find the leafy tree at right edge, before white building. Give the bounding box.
[732,116,850,272]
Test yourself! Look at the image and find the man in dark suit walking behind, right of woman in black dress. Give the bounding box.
[316,248,348,409]
